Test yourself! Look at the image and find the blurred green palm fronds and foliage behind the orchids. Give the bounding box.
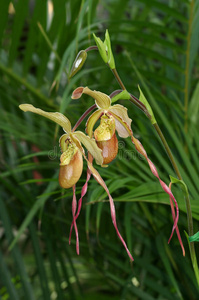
[0,0,199,300]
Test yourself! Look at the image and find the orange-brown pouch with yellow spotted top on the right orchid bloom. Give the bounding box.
[94,114,118,164]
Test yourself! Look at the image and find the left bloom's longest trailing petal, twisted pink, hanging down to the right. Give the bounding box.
[84,156,134,261]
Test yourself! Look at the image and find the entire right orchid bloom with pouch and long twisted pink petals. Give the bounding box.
[72,87,184,254]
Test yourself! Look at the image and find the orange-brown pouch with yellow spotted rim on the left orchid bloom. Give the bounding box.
[59,138,83,189]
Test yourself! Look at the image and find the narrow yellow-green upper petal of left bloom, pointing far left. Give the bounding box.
[19,104,71,133]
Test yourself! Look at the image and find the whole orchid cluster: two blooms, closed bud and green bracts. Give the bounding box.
[19,32,185,261]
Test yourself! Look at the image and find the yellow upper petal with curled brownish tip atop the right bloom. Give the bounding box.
[71,87,111,109]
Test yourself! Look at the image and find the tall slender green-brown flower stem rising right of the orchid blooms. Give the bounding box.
[112,69,199,286]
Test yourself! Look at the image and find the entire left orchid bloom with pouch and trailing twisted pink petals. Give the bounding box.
[19,104,133,261]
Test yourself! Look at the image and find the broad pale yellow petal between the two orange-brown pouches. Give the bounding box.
[71,131,103,165]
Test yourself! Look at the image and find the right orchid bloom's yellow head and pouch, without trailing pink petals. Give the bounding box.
[72,87,132,164]
